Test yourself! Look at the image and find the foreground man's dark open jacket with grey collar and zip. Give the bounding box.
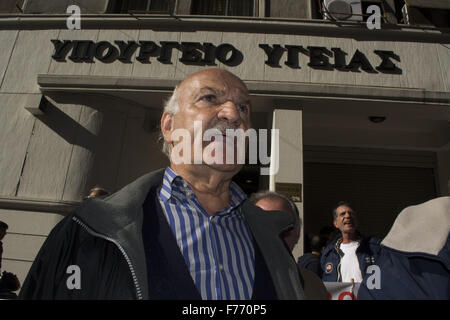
[19,169,304,299]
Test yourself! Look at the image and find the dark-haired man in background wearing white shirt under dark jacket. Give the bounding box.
[320,201,379,282]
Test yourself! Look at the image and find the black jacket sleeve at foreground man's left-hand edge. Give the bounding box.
[19,214,78,299]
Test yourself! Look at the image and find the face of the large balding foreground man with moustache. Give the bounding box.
[162,69,250,172]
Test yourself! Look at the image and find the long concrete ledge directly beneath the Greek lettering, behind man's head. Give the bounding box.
[38,75,450,104]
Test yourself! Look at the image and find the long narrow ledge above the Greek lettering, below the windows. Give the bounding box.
[0,14,450,43]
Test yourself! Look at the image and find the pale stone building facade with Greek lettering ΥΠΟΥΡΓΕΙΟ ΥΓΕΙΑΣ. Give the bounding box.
[0,0,450,288]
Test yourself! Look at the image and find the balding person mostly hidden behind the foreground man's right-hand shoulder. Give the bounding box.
[250,191,328,300]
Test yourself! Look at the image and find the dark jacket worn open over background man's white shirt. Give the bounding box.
[320,232,380,282]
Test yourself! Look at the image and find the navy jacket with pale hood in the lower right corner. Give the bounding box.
[358,197,450,300]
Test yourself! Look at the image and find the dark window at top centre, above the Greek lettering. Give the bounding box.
[191,0,255,16]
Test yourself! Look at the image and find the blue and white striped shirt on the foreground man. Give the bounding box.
[158,167,255,300]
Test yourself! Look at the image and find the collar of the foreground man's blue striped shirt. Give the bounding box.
[159,167,247,212]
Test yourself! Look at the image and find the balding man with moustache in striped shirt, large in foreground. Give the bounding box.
[20,69,304,300]
